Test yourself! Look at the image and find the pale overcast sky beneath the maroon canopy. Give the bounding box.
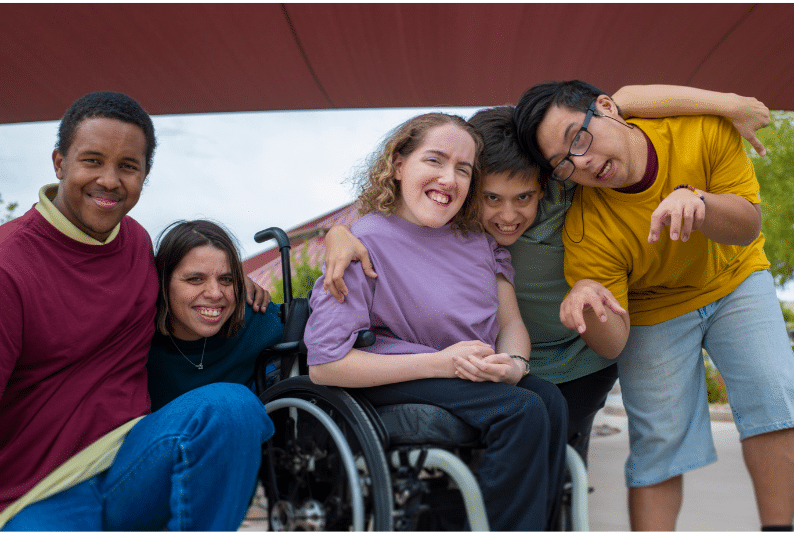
[0,108,794,301]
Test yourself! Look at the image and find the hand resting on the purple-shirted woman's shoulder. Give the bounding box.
[323,225,378,303]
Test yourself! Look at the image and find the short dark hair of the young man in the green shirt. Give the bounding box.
[469,106,547,190]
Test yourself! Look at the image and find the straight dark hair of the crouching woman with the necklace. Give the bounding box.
[154,220,245,338]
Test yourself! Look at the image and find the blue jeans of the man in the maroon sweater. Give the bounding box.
[3,383,273,531]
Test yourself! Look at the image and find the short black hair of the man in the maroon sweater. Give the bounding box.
[55,91,157,175]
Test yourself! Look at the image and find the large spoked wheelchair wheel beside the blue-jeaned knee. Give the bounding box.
[260,377,393,531]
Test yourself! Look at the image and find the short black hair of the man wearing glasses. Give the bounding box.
[513,80,609,171]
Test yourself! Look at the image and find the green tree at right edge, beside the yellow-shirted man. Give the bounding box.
[746,112,794,286]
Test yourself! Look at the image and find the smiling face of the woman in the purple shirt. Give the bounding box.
[394,124,476,227]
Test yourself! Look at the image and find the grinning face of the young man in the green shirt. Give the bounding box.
[480,171,543,246]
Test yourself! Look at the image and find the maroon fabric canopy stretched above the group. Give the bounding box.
[0,4,794,123]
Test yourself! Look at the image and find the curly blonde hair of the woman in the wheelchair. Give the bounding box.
[356,113,483,234]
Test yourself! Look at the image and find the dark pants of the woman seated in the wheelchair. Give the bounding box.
[359,375,568,531]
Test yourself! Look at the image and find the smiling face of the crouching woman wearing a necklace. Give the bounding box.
[168,245,236,341]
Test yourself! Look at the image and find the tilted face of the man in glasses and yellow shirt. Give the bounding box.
[537,95,647,188]
